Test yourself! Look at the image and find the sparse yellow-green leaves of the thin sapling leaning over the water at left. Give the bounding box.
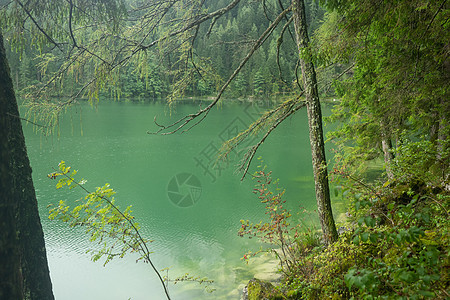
[48,161,150,265]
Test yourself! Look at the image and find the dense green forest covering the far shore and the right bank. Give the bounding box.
[0,0,450,299]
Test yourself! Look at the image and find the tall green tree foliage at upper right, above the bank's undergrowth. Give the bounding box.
[324,0,450,176]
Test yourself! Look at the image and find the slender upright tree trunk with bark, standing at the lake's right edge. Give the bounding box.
[292,0,338,244]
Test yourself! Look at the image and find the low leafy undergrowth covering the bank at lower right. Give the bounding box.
[279,148,450,299]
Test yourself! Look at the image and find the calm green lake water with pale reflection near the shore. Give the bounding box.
[24,102,343,300]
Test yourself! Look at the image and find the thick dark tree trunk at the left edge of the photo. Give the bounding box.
[0,34,54,300]
